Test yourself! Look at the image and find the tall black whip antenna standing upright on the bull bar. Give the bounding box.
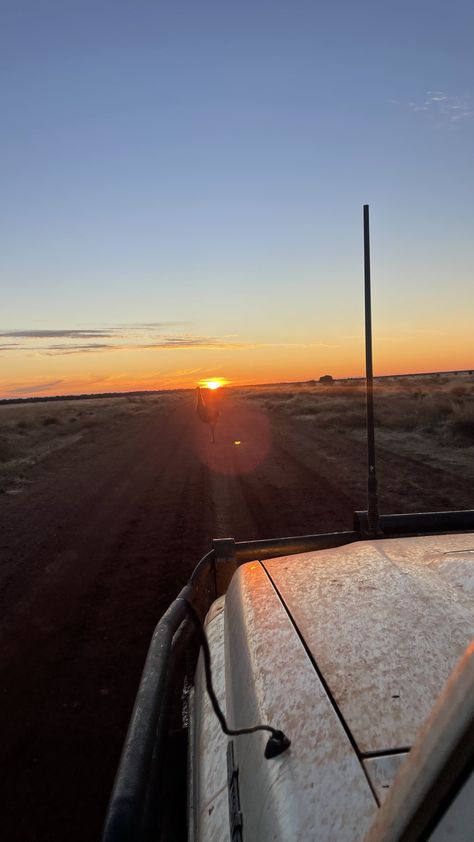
[364,205,380,535]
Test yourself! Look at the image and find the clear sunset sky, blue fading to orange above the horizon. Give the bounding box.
[0,0,474,397]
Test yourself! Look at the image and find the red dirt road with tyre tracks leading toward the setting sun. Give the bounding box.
[0,396,472,842]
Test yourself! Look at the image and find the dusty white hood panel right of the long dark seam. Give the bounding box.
[265,535,474,754]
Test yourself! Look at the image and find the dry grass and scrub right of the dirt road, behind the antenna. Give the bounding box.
[240,372,474,498]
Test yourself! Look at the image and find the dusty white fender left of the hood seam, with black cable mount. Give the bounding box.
[194,562,377,842]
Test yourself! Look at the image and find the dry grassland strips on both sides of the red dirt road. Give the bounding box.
[0,373,474,493]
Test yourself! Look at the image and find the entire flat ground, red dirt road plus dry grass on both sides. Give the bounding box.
[0,373,474,842]
